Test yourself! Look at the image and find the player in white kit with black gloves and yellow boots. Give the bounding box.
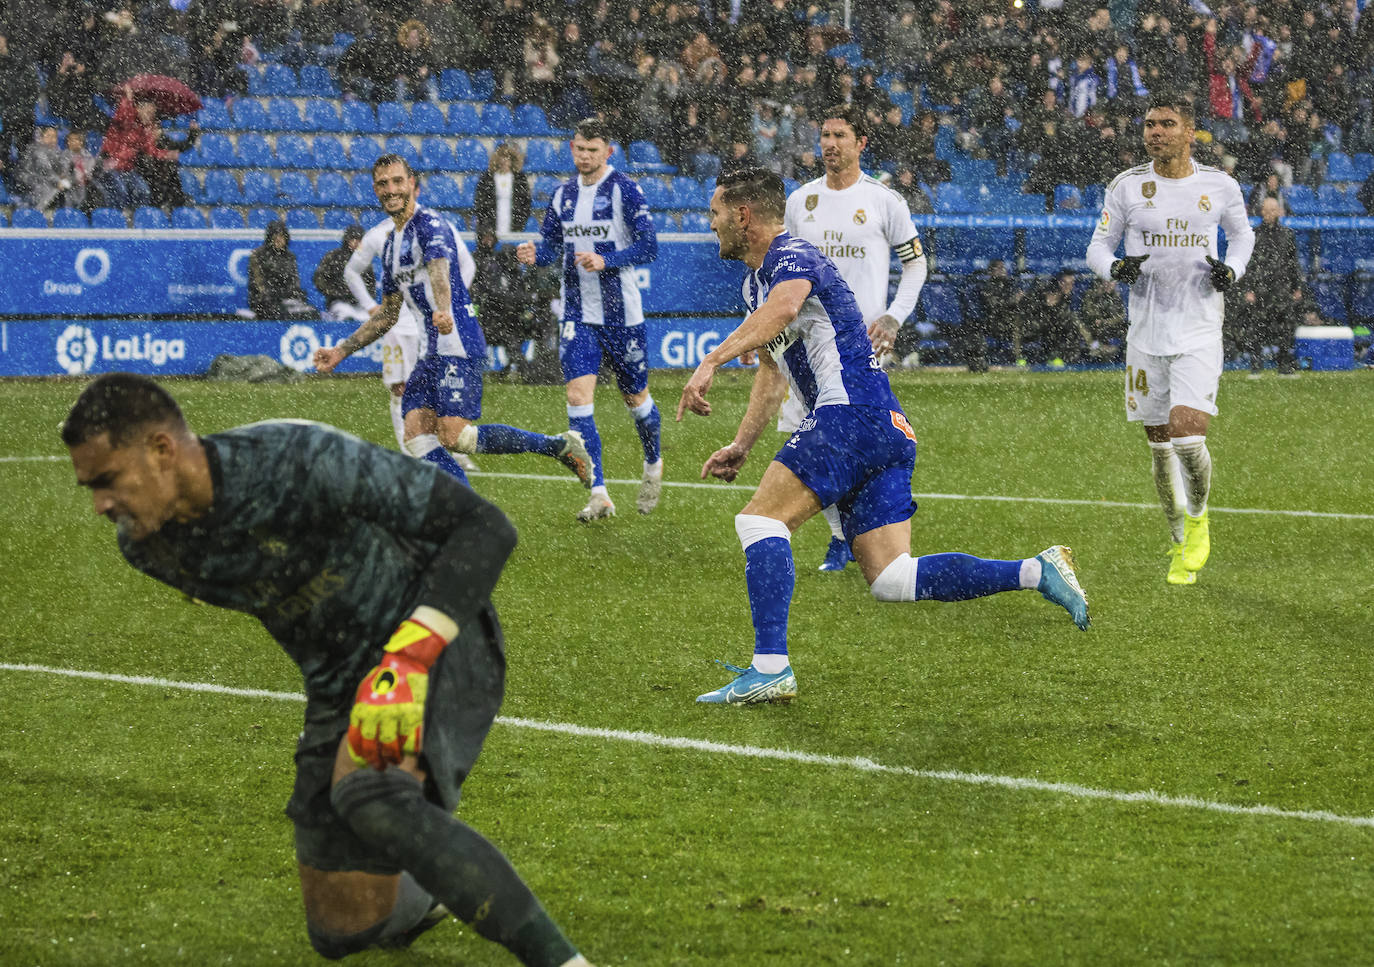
[1088,93,1254,584]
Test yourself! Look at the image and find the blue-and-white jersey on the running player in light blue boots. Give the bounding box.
[743,232,901,412]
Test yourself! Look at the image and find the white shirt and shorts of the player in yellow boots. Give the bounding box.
[1087,162,1254,426]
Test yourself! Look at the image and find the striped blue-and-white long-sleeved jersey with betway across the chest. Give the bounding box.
[534,165,658,326]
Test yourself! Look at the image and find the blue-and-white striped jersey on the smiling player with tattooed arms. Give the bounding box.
[382,206,486,359]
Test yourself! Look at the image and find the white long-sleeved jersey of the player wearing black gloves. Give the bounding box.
[1088,162,1254,356]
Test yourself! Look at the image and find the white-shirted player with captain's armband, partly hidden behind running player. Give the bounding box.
[778,104,926,571]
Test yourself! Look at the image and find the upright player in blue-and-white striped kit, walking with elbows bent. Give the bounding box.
[515,118,664,521]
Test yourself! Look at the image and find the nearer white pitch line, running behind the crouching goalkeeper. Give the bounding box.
[10,662,1374,828]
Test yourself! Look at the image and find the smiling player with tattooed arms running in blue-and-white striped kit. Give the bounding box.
[315,154,592,486]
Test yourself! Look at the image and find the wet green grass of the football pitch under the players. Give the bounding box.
[0,372,1374,967]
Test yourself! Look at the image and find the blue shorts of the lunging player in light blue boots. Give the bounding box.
[774,407,916,541]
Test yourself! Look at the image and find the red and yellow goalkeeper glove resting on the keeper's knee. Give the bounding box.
[348,607,458,769]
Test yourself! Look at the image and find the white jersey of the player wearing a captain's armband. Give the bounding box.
[783,174,921,323]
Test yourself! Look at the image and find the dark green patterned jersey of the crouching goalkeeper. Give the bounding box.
[120,420,515,740]
